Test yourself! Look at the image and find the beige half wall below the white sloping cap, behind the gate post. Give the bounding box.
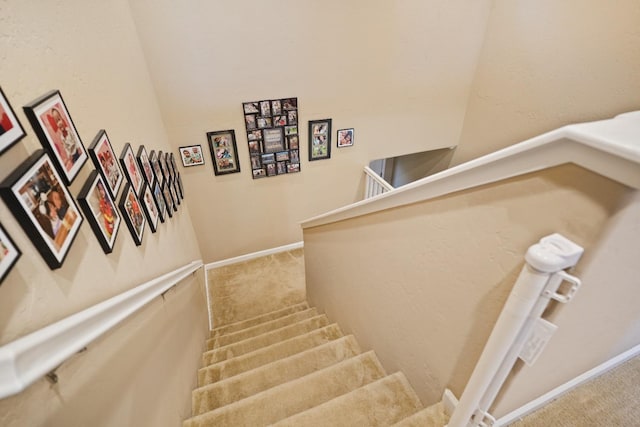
[304,165,640,409]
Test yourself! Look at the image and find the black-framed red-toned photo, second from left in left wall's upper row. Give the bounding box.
[23,90,88,185]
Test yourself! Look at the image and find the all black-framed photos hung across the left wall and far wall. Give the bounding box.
[0,87,354,284]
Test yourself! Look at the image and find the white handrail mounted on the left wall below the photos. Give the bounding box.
[0,260,202,399]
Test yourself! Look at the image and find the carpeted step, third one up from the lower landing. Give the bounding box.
[203,314,329,363]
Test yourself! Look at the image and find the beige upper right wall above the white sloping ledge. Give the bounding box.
[453,0,640,164]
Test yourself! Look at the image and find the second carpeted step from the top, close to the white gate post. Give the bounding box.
[274,372,422,427]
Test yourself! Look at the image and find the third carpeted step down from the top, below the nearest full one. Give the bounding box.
[183,351,385,427]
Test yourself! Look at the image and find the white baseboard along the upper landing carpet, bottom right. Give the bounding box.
[494,344,640,427]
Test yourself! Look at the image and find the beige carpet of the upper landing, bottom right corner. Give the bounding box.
[511,357,640,427]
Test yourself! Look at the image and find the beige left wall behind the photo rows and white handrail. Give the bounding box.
[0,0,207,426]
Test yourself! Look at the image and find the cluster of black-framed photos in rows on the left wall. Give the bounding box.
[0,88,184,284]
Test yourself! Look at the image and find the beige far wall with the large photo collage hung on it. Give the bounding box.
[131,0,490,262]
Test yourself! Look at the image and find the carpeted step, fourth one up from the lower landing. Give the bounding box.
[198,323,343,387]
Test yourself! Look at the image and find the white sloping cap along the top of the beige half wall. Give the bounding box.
[301,111,640,228]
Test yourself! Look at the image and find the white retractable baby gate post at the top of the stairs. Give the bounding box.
[448,234,584,427]
